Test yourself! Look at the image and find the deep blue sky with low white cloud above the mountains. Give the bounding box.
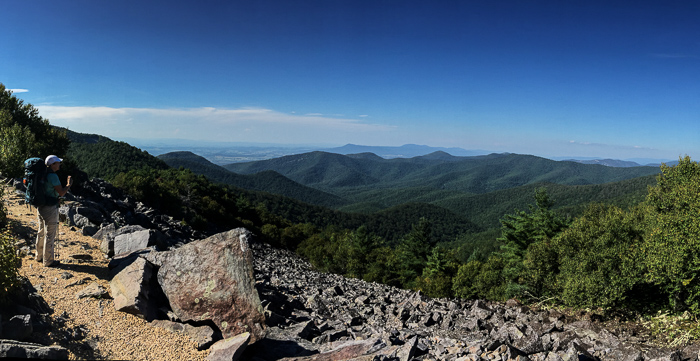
[0,0,700,160]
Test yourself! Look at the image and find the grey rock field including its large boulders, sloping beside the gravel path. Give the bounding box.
[0,180,698,361]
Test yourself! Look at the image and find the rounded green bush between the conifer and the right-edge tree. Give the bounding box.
[556,204,645,308]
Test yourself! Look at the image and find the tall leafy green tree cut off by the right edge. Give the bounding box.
[644,156,700,314]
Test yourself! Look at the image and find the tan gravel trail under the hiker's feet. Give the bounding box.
[3,188,209,360]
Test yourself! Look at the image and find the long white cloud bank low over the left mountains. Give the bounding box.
[36,105,396,143]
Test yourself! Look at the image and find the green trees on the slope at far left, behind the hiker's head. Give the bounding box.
[0,84,69,177]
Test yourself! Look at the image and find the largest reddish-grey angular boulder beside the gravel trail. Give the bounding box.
[144,228,265,343]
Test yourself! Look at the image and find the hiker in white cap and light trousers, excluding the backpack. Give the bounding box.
[36,155,73,267]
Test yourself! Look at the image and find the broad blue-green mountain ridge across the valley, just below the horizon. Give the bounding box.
[224,152,659,197]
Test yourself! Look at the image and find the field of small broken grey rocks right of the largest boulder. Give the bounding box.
[249,244,698,361]
